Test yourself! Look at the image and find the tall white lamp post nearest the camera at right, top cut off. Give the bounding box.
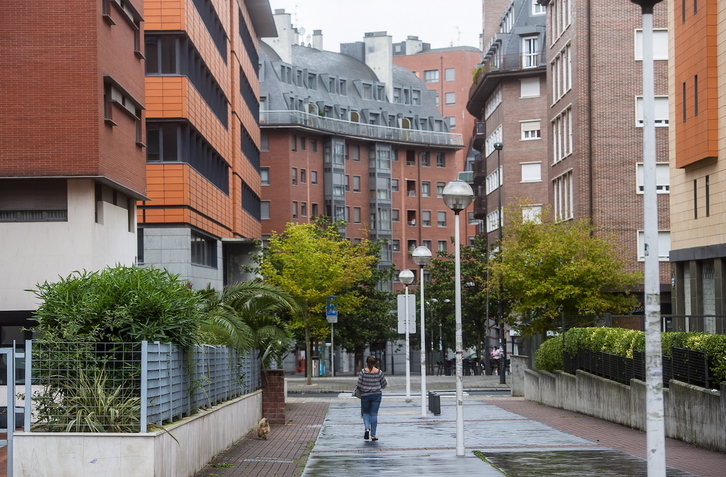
[631,0,666,477]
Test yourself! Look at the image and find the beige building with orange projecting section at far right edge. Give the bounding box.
[672,0,726,324]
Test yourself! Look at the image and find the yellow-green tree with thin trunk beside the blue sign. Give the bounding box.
[260,221,376,384]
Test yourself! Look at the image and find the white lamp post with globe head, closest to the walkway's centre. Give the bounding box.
[442,180,474,457]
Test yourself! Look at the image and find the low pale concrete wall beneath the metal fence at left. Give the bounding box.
[13,391,262,477]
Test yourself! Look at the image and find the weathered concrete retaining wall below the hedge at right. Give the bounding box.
[522,369,726,452]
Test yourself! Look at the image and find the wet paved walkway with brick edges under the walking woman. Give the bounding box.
[196,376,726,477]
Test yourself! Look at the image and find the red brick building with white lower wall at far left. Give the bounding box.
[0,0,147,345]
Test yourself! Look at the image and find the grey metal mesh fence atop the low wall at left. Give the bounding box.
[25,341,261,432]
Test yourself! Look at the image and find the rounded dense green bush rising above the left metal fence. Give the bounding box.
[30,265,202,348]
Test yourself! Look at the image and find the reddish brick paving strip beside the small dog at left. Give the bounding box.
[195,401,328,477]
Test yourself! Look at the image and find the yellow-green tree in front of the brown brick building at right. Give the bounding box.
[490,208,641,336]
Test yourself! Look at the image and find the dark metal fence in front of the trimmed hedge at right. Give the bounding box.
[563,348,718,388]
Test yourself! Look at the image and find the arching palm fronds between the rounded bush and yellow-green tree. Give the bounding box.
[198,280,299,367]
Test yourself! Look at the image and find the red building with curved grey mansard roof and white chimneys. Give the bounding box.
[260,10,463,289]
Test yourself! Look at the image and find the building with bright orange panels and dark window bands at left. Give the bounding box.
[138,0,277,289]
